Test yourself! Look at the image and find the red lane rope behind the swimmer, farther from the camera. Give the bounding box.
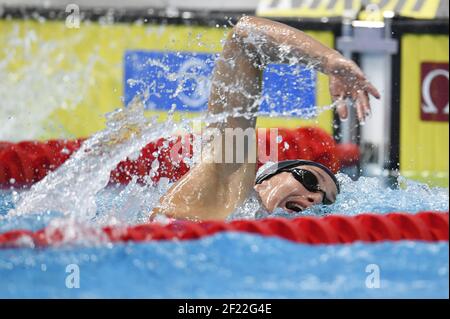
[0,127,352,188]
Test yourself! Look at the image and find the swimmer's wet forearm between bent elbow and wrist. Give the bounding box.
[231,17,343,74]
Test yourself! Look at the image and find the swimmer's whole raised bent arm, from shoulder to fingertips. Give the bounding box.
[152,17,379,219]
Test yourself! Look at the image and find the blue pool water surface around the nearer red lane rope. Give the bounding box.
[0,179,449,298]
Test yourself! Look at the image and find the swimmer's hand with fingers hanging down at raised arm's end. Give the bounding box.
[325,52,380,122]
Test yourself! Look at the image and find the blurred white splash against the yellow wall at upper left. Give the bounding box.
[0,25,98,141]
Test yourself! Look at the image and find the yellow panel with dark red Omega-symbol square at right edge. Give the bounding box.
[400,34,449,187]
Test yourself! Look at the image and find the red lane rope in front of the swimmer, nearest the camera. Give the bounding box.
[0,212,449,248]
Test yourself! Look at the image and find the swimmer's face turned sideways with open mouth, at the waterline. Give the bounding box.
[255,165,338,213]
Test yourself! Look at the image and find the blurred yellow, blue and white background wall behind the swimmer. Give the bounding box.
[0,0,449,186]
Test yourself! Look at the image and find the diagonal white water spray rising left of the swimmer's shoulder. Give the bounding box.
[9,97,174,219]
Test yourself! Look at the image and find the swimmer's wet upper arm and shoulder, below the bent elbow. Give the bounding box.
[153,18,261,219]
